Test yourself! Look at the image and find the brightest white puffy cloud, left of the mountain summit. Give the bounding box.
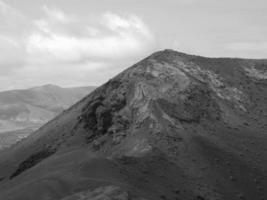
[26,7,154,62]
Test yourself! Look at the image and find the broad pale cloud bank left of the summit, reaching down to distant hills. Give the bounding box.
[0,0,155,90]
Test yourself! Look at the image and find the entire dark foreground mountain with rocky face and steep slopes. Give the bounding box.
[0,50,267,200]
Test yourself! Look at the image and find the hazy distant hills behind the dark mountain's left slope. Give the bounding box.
[0,84,95,148]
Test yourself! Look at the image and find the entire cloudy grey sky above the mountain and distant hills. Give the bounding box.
[0,0,267,90]
